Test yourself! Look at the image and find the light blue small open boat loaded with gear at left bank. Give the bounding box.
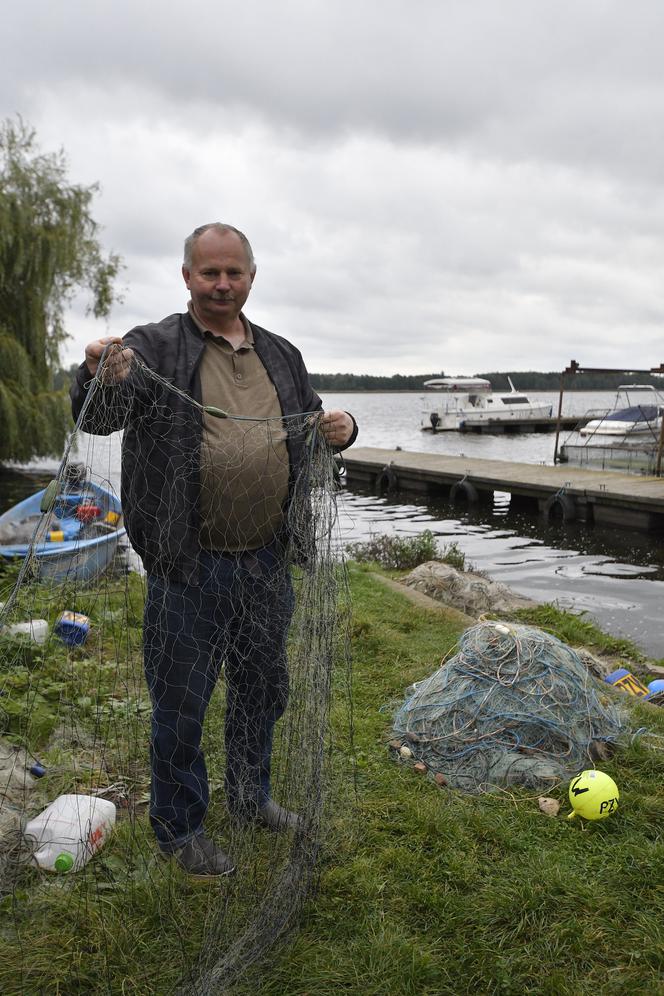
[0,477,126,582]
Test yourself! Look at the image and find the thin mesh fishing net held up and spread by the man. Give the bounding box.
[0,351,351,994]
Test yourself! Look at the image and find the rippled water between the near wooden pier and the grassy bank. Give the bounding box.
[342,491,664,657]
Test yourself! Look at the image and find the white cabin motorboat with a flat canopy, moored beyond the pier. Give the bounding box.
[422,377,551,432]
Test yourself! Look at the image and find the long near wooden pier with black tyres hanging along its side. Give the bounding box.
[344,446,664,530]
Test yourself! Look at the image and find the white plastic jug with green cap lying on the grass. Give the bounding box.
[24,795,115,873]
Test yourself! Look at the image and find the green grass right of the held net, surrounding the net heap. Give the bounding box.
[237,567,664,996]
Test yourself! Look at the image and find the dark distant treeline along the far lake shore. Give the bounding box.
[309,370,664,391]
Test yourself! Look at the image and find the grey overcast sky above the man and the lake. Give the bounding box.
[5,0,664,374]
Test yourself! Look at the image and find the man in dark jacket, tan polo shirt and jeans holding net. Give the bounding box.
[71,223,357,878]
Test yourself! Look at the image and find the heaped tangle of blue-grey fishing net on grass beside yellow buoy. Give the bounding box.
[393,623,622,793]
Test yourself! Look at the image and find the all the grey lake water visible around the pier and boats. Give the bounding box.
[0,392,664,658]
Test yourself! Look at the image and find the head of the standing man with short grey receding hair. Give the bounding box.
[182,228,254,330]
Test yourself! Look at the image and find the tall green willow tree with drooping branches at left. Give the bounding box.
[0,119,120,461]
